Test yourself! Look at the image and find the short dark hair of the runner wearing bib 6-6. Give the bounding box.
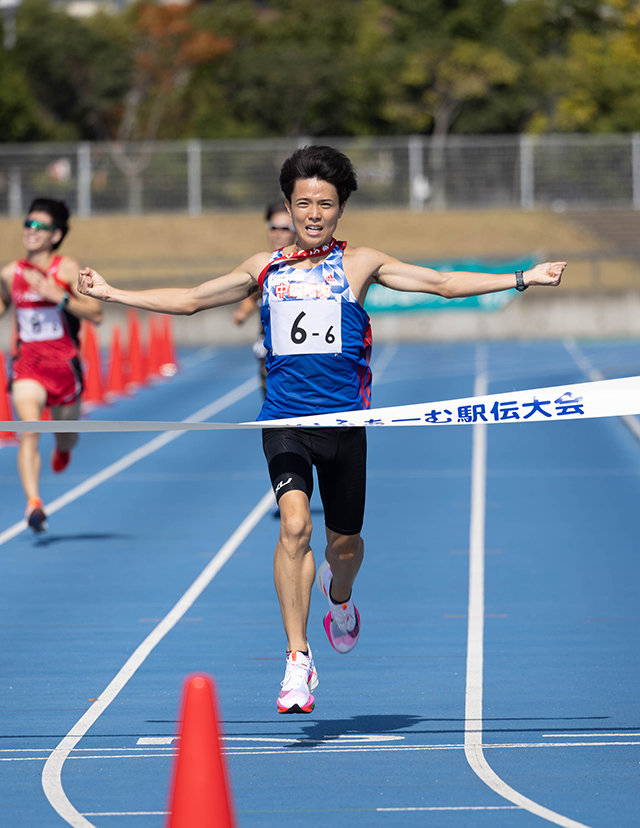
[280,145,358,204]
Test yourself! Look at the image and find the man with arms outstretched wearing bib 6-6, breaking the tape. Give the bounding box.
[79,146,566,713]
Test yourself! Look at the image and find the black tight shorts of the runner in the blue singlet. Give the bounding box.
[262,426,367,535]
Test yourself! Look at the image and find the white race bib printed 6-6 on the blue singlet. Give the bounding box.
[269,299,342,356]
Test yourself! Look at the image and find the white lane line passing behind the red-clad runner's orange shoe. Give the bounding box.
[0,377,258,546]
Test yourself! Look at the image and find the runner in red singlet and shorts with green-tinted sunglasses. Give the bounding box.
[0,198,102,532]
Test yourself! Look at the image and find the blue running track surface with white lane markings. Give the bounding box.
[0,342,640,828]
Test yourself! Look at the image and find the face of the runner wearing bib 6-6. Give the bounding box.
[288,178,344,250]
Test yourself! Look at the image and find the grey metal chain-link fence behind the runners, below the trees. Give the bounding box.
[0,133,640,216]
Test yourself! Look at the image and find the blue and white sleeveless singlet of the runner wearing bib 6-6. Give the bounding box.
[258,239,371,420]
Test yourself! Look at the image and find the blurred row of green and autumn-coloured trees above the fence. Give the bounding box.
[5,0,640,144]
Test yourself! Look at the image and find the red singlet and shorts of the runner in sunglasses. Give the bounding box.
[11,256,82,405]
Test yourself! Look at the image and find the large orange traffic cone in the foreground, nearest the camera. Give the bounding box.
[167,675,236,828]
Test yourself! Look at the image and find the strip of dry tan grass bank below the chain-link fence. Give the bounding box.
[0,205,640,290]
